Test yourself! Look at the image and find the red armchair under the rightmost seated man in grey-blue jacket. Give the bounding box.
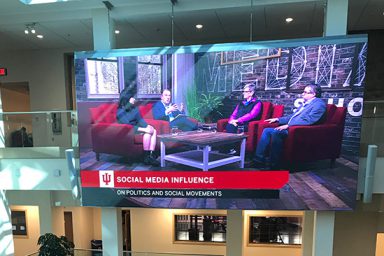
[258,104,347,165]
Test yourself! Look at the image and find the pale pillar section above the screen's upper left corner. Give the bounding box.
[92,8,115,50]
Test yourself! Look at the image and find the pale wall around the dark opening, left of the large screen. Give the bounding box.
[0,49,71,146]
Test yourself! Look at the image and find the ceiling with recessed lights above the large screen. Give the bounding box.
[0,0,384,51]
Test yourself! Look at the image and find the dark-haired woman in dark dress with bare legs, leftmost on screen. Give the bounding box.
[116,87,159,166]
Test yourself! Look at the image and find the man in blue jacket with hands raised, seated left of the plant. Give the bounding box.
[152,89,197,131]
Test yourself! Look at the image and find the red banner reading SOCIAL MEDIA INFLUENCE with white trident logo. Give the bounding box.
[81,170,289,189]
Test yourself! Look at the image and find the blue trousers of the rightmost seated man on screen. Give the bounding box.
[255,128,288,164]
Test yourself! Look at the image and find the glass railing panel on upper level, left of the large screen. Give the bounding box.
[0,110,78,148]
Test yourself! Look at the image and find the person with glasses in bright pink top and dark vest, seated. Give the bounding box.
[225,84,263,133]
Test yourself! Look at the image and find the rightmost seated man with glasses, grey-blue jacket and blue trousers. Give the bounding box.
[254,85,326,169]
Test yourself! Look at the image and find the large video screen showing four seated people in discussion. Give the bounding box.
[75,35,367,210]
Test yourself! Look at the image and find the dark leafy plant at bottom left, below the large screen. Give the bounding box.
[37,233,75,256]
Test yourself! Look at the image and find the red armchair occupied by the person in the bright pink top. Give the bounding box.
[217,101,284,153]
